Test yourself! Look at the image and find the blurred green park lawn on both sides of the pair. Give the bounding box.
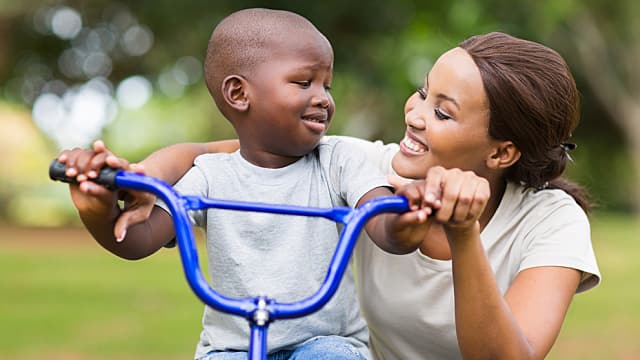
[0,215,640,360]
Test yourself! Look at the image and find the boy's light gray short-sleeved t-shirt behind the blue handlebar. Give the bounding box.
[159,137,388,357]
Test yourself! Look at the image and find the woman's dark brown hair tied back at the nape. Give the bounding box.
[459,32,591,212]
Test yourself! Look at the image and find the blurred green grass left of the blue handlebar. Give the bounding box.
[0,229,203,360]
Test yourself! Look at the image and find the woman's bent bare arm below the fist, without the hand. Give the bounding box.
[449,231,580,359]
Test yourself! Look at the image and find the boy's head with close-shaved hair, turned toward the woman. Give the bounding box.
[205,9,335,162]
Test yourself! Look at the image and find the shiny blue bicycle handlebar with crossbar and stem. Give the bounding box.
[49,160,409,360]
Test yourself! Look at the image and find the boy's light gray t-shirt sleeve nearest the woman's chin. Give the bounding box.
[330,139,391,207]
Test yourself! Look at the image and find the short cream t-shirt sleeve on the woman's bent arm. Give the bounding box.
[519,204,601,292]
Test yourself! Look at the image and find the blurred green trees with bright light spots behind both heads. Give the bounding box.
[0,0,640,224]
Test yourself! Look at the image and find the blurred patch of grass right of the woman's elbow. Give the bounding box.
[548,212,640,360]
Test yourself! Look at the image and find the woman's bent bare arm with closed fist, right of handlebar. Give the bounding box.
[424,167,580,359]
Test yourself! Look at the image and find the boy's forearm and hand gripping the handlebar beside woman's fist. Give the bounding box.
[357,187,431,254]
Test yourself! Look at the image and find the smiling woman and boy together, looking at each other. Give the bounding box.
[59,5,600,360]
